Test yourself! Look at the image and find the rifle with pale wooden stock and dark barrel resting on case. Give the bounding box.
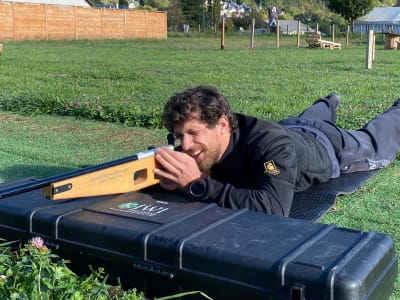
[0,145,174,200]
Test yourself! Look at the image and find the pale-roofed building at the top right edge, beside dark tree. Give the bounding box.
[353,6,400,35]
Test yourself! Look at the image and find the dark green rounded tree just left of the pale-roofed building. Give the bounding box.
[328,0,375,23]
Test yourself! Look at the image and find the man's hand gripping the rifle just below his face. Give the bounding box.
[154,147,202,191]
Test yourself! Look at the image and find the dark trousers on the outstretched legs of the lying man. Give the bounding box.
[288,98,400,173]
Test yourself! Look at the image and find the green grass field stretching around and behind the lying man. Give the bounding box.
[0,35,400,299]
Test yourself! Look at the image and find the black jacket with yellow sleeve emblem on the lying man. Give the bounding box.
[192,114,332,216]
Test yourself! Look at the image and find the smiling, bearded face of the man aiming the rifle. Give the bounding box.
[174,114,230,174]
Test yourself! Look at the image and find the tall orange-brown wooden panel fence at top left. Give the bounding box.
[0,2,167,41]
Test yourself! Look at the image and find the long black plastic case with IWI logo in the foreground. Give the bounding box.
[0,179,397,300]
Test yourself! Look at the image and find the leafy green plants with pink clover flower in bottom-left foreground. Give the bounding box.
[0,237,145,300]
